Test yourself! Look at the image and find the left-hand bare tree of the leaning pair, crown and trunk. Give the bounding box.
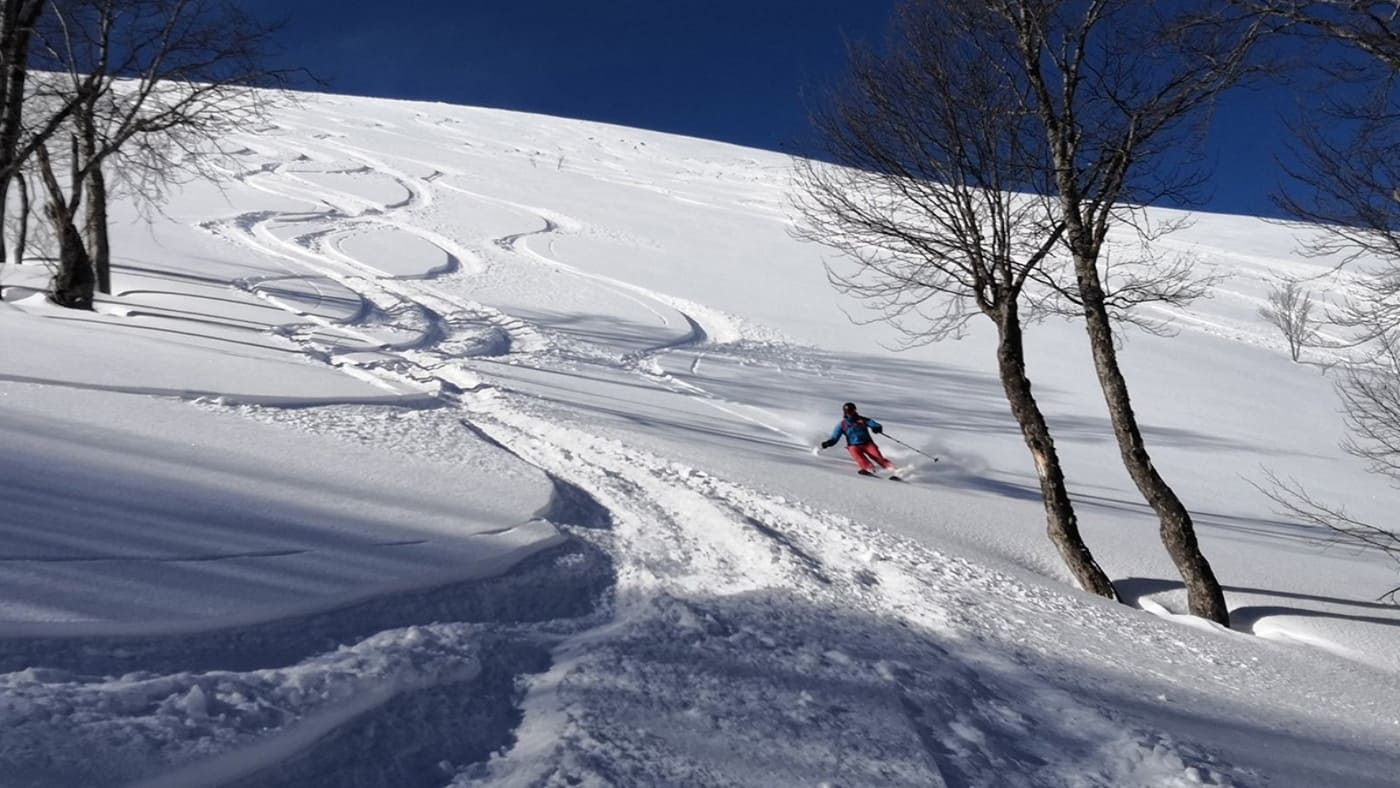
[794,1,1117,599]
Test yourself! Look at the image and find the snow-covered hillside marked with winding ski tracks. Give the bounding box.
[0,97,1400,787]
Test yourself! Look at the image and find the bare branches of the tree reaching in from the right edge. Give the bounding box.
[1232,0,1400,600]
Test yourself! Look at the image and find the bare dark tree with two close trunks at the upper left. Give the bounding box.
[29,0,291,308]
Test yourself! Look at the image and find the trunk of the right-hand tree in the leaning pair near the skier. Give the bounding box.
[1074,252,1229,627]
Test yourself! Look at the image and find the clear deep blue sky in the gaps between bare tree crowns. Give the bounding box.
[242,0,1288,214]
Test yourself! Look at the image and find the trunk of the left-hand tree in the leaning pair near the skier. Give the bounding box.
[997,302,1119,600]
